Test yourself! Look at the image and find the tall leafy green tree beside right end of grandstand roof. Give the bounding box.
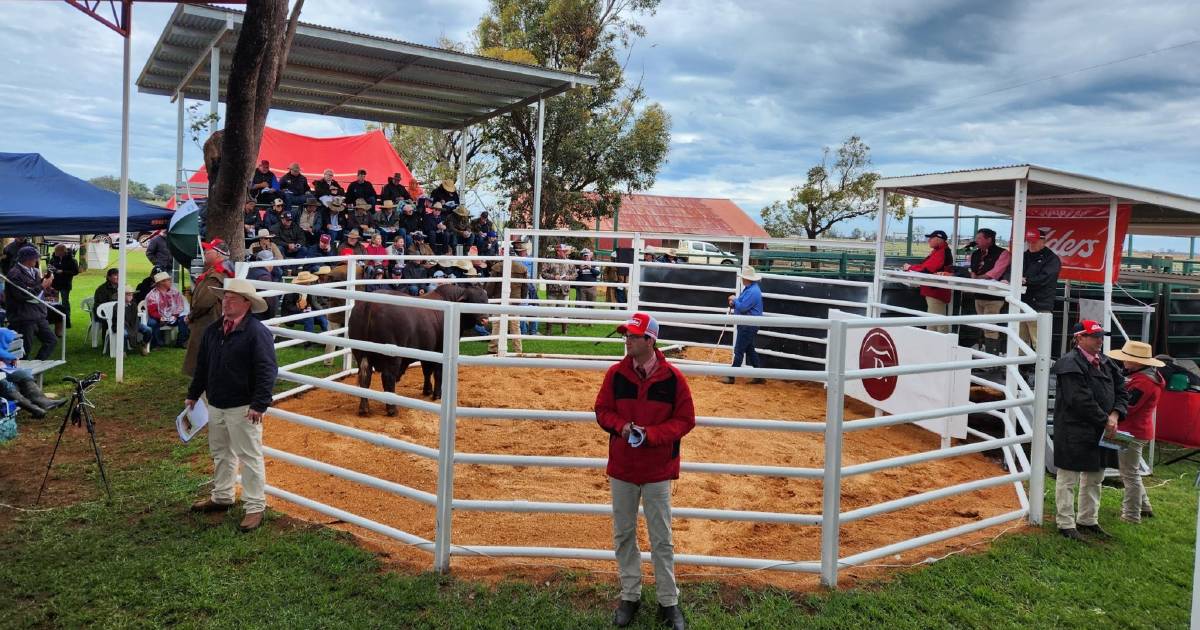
[475,0,671,250]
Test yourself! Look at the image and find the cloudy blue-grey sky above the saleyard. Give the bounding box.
[0,0,1200,244]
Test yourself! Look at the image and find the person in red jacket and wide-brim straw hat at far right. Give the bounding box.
[1106,341,1163,523]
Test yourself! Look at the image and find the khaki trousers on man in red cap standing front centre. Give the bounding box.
[608,476,679,606]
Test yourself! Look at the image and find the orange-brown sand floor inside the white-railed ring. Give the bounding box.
[264,350,1020,588]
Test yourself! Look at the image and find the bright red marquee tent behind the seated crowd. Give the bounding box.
[174,127,424,206]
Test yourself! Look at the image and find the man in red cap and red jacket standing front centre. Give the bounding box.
[595,313,696,630]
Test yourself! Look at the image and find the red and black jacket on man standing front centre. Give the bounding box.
[595,349,696,484]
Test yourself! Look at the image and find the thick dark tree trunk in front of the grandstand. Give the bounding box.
[208,0,304,260]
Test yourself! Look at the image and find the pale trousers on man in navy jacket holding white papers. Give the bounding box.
[209,406,266,514]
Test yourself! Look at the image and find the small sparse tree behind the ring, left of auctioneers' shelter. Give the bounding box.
[761,136,905,239]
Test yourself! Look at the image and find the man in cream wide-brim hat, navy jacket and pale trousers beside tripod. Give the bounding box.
[185,278,278,532]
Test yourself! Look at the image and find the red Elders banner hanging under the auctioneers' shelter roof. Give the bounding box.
[1025,205,1132,282]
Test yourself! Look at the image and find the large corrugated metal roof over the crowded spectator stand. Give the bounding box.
[137,5,596,128]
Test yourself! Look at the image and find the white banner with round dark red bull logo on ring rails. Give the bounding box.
[829,308,971,439]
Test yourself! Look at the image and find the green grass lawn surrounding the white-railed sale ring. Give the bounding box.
[0,266,1198,629]
